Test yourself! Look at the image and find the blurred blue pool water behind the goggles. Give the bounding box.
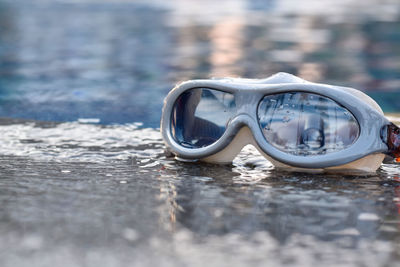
[0,0,400,127]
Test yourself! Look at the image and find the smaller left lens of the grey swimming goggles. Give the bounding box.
[171,88,236,148]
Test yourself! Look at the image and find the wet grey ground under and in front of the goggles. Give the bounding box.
[0,122,400,266]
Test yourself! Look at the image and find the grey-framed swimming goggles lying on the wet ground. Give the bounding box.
[161,73,400,171]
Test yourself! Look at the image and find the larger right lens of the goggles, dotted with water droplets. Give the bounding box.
[257,92,360,156]
